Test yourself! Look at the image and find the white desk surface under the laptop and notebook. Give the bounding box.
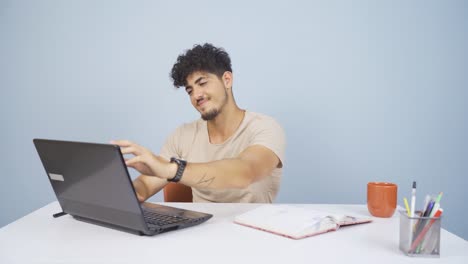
[0,202,468,264]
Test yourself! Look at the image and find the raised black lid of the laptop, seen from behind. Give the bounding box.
[34,139,145,228]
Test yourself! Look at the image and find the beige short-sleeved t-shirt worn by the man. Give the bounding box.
[161,111,286,203]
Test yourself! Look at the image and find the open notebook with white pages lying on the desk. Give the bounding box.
[234,204,372,239]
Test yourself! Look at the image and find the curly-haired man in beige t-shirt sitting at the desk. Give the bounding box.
[113,44,285,203]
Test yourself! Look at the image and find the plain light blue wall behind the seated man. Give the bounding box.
[0,0,468,239]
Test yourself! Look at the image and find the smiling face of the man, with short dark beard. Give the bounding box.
[185,72,228,120]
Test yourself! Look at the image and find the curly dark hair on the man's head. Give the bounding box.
[171,43,232,88]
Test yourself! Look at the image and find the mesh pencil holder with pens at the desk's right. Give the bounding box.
[399,211,442,257]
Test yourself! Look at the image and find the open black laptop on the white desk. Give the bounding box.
[33,139,212,236]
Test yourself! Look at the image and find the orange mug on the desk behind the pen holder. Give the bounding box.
[367,182,398,217]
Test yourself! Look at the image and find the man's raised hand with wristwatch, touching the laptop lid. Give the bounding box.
[111,140,169,179]
